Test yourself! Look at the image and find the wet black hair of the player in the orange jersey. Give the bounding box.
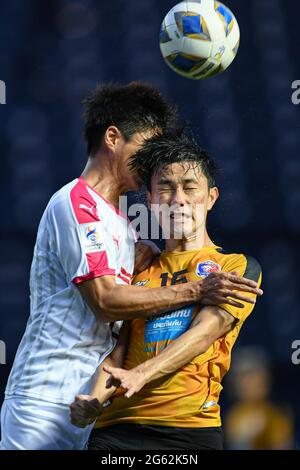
[130,132,217,191]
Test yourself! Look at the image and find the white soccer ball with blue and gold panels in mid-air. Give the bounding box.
[160,0,240,80]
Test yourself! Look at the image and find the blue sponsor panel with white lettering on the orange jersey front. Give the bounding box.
[145,305,195,351]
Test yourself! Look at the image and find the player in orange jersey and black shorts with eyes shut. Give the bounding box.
[71,131,261,450]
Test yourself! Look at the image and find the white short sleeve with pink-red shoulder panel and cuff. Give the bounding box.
[49,181,116,285]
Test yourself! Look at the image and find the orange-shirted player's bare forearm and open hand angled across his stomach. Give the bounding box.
[104,306,236,398]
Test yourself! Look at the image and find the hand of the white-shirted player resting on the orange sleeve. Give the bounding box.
[199,271,263,308]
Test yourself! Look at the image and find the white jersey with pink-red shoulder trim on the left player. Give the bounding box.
[5,178,136,404]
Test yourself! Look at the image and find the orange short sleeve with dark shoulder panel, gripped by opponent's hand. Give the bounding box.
[219,254,262,321]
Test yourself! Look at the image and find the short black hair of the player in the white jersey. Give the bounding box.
[83,82,176,156]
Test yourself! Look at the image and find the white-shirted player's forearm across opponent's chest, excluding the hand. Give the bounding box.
[94,282,201,321]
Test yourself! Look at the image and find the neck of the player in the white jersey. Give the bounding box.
[81,153,130,208]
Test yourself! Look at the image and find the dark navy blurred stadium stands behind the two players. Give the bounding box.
[0,0,300,450]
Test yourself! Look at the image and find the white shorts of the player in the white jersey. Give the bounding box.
[0,397,93,450]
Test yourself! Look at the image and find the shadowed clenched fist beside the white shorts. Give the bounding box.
[70,395,103,428]
